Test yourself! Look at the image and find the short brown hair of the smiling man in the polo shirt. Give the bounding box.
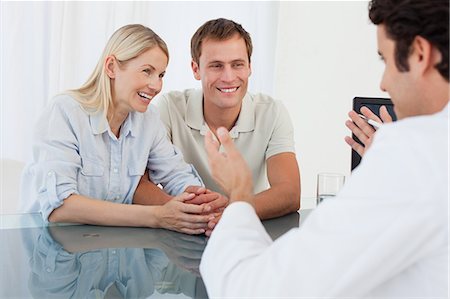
[191,18,253,65]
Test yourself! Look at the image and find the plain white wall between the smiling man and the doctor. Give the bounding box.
[274,1,383,197]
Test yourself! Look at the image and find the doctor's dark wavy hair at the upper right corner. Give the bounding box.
[369,0,449,81]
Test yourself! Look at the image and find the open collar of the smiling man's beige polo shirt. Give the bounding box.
[185,90,255,138]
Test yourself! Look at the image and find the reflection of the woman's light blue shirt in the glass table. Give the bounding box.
[28,228,170,299]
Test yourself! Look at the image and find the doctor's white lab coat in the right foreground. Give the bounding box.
[200,105,449,298]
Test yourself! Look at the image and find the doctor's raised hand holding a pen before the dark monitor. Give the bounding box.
[345,106,392,157]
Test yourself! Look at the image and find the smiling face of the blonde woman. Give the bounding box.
[110,47,168,112]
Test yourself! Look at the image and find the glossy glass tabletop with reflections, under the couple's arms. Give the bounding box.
[0,210,309,298]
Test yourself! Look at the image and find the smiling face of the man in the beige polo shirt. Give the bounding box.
[192,34,251,109]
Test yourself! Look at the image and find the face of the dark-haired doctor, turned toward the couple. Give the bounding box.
[377,25,426,119]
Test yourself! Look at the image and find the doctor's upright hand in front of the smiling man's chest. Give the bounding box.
[205,127,253,204]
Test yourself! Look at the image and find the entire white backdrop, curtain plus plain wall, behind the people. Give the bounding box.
[0,1,390,213]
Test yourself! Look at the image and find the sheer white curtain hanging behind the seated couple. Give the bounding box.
[1,1,278,161]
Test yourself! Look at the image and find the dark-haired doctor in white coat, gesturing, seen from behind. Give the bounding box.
[200,0,450,298]
